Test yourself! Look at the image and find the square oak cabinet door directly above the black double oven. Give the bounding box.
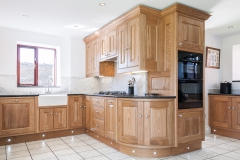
[178,16,204,53]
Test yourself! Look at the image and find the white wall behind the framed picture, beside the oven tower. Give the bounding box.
[204,34,225,133]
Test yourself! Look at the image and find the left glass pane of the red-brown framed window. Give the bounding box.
[20,48,34,85]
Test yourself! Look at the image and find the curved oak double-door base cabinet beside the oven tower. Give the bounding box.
[117,99,175,146]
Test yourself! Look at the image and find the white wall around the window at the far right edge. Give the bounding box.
[220,34,240,90]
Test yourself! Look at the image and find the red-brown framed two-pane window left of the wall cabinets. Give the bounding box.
[17,44,57,87]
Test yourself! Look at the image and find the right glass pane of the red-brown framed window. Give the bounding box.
[38,49,55,86]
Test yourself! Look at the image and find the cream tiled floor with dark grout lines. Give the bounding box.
[0,134,240,160]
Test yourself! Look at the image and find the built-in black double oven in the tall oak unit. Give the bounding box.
[178,51,203,109]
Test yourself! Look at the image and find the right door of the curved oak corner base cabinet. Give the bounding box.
[144,100,175,146]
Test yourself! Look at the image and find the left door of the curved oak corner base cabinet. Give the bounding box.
[118,100,143,145]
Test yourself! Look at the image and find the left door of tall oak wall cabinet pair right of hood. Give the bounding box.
[117,23,128,69]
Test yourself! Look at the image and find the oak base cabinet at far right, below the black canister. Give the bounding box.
[209,95,240,138]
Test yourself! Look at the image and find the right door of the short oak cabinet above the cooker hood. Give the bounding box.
[107,29,117,57]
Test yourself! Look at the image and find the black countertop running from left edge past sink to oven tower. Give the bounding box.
[0,93,176,99]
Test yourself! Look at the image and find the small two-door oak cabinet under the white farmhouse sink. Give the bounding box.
[39,106,67,132]
